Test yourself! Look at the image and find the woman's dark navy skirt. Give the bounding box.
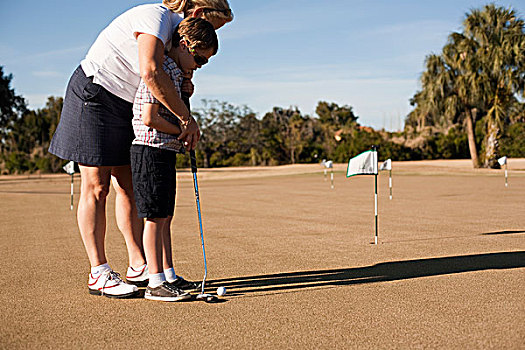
[49,66,135,166]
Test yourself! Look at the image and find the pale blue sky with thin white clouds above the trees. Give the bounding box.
[0,0,525,130]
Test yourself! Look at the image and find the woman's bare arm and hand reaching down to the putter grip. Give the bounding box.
[137,34,200,150]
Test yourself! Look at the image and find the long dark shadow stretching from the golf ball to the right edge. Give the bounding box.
[210,251,525,296]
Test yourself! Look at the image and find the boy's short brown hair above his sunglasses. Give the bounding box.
[171,17,219,55]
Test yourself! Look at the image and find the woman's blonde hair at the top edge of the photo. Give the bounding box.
[162,0,233,22]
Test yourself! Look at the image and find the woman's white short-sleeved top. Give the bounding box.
[80,4,183,102]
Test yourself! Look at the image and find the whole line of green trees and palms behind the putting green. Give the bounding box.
[0,4,525,174]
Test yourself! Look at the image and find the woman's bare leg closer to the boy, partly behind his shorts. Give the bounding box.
[111,165,146,268]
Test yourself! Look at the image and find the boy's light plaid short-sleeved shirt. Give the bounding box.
[132,56,184,153]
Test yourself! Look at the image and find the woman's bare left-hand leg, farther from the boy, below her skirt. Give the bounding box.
[77,165,111,267]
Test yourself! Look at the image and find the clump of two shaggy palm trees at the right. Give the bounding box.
[409,4,525,167]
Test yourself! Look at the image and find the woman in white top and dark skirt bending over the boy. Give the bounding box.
[49,0,233,298]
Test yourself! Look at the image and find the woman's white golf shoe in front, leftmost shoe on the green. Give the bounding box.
[88,270,139,298]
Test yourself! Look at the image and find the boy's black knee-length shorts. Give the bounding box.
[130,145,177,218]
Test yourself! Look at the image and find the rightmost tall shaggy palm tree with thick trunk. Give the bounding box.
[462,4,525,168]
